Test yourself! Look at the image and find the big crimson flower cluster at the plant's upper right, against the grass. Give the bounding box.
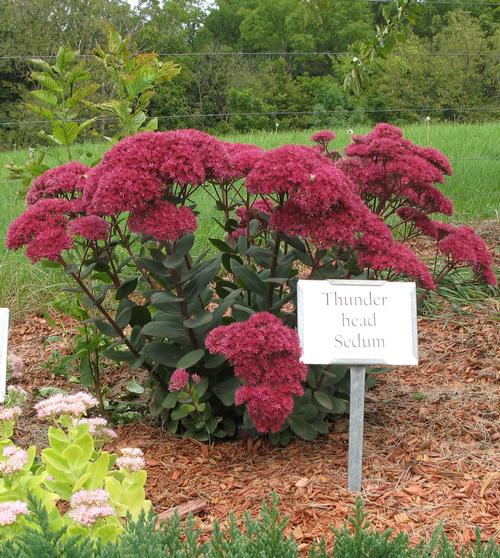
[338,124,453,215]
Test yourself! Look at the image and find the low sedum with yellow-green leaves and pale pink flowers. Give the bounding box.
[0,386,151,541]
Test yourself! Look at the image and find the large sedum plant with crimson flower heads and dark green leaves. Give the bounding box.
[7,124,496,444]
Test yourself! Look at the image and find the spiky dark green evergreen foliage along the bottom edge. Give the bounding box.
[0,498,500,558]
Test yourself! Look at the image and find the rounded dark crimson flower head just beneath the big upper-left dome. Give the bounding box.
[128,200,196,242]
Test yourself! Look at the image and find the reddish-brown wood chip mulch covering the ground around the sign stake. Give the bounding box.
[4,299,500,549]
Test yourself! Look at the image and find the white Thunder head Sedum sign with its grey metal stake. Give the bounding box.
[297,280,418,492]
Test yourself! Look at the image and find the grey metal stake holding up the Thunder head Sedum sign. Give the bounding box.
[347,366,366,492]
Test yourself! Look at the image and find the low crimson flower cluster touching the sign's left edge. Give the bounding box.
[205,312,307,432]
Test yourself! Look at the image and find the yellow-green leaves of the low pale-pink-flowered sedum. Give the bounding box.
[0,389,151,544]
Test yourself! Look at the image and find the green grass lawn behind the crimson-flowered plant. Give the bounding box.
[0,123,500,316]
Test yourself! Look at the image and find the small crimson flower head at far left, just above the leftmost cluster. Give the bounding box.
[26,161,90,205]
